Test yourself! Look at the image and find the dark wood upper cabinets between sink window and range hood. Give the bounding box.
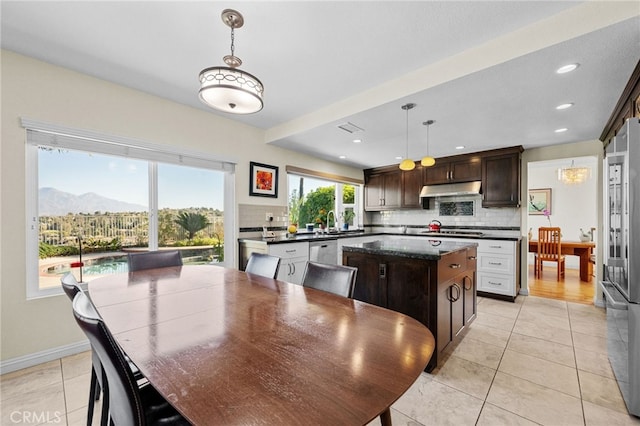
[364,166,423,211]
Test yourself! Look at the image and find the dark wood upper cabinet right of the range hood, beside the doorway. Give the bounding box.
[482,146,523,207]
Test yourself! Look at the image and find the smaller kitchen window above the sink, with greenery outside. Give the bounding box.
[287,172,362,232]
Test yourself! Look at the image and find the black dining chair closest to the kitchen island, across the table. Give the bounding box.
[302,261,358,298]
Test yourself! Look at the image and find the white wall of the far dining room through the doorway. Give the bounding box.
[527,156,599,269]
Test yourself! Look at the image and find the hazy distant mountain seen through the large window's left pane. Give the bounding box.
[38,188,147,216]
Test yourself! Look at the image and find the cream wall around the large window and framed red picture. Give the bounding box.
[0,50,363,364]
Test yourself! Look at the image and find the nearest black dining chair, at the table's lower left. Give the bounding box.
[73,292,189,426]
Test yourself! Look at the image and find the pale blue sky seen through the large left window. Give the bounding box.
[38,150,224,210]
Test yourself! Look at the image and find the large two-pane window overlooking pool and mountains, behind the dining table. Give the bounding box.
[25,120,234,297]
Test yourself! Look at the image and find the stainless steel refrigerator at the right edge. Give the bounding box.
[602,118,640,416]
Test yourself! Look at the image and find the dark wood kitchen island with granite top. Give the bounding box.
[342,239,477,371]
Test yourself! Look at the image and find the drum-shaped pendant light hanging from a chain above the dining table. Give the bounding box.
[199,9,264,114]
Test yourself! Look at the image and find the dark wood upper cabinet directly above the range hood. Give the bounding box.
[424,155,482,185]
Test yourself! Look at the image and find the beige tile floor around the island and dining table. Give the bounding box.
[0,296,640,426]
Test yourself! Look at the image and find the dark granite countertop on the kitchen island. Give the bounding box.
[342,239,477,260]
